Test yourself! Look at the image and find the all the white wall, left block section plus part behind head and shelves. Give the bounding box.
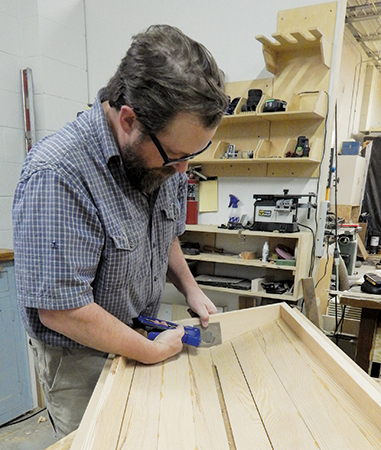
[0,0,343,248]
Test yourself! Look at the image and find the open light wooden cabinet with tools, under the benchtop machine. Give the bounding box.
[181,225,312,302]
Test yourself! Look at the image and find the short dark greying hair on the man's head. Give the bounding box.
[107,25,228,133]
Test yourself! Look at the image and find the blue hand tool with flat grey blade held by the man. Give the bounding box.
[135,316,222,347]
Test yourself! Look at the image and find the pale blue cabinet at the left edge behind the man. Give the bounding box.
[0,251,33,425]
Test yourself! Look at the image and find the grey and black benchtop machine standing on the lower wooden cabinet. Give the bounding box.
[252,189,316,233]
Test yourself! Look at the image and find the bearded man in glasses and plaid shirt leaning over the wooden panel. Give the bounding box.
[13,25,227,438]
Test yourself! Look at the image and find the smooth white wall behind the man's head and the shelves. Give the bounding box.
[85,0,336,224]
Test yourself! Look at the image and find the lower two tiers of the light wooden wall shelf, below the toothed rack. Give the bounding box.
[190,88,327,178]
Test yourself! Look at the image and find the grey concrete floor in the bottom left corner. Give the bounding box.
[0,410,56,450]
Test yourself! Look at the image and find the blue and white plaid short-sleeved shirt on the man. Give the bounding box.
[13,89,186,347]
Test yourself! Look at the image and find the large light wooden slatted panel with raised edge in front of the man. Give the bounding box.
[46,303,381,450]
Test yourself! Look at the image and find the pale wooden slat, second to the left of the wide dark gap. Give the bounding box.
[157,352,196,450]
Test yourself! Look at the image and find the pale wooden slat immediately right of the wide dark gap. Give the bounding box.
[211,342,272,450]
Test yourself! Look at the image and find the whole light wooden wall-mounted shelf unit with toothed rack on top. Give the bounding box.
[190,17,333,178]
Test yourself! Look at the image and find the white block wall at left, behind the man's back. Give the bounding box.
[0,0,88,248]
